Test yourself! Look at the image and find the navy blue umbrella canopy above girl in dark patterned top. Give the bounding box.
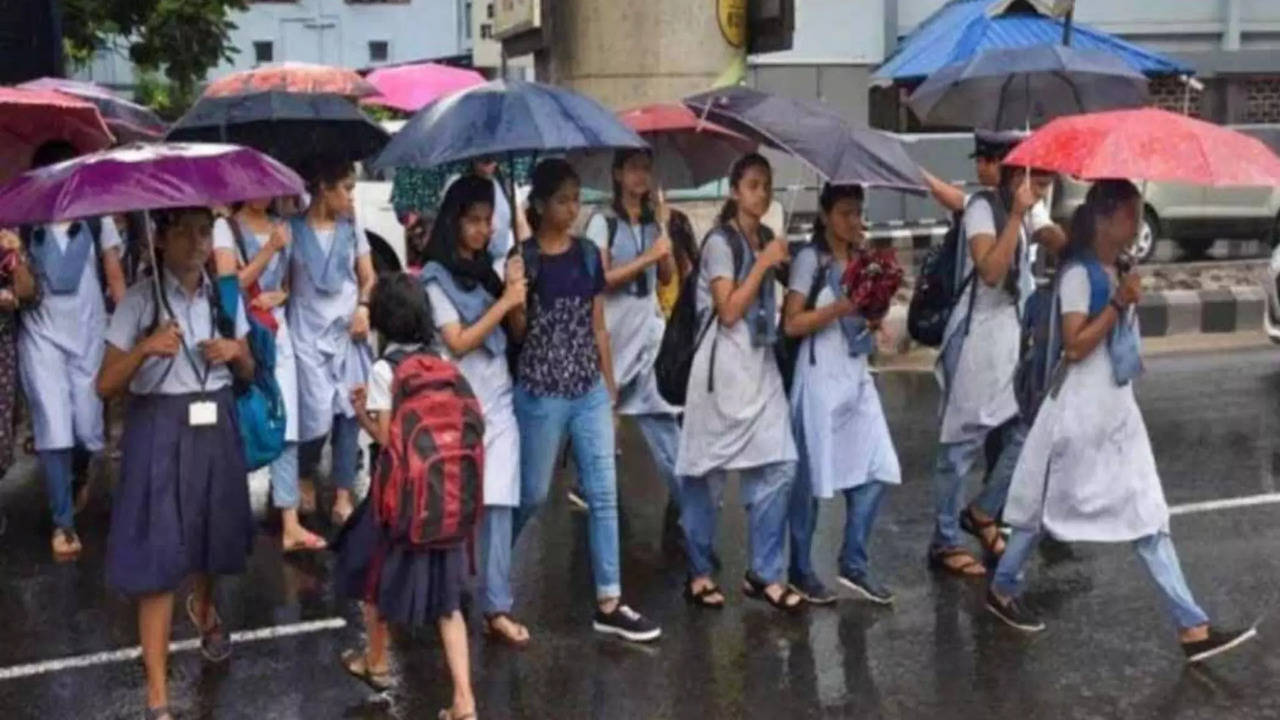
[374,81,648,168]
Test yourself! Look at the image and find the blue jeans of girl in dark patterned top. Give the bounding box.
[515,379,622,600]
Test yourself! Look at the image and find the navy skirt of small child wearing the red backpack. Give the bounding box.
[333,498,466,625]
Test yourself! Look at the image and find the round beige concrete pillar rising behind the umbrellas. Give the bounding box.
[538,0,746,109]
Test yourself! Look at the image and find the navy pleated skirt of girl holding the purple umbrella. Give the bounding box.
[106,388,253,594]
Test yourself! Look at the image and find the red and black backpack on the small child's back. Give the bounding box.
[372,352,484,547]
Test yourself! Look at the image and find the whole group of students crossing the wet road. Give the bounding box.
[2,128,1252,720]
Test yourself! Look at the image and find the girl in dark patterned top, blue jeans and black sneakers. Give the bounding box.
[512,159,662,642]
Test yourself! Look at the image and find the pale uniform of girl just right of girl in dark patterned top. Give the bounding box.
[585,214,680,500]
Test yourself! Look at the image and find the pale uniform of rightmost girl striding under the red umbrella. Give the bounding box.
[993,263,1208,628]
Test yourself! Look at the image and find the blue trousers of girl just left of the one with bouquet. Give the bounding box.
[680,461,796,584]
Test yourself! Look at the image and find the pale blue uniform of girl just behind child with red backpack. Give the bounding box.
[287,215,372,489]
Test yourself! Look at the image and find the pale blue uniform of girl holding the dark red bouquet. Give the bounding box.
[787,245,902,583]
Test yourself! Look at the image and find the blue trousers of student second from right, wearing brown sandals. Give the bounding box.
[931,418,1029,550]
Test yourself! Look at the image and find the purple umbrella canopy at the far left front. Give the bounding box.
[0,143,303,225]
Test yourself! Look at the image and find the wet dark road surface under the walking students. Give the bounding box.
[0,348,1280,720]
